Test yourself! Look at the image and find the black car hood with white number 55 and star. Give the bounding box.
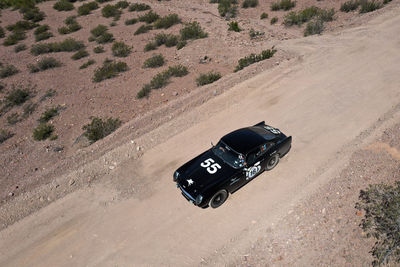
[177,149,237,197]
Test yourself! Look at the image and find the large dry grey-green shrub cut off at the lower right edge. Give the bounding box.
[356,181,400,266]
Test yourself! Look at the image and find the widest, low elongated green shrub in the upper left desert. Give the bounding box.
[31,38,85,56]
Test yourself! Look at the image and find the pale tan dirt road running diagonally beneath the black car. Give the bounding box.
[0,4,400,266]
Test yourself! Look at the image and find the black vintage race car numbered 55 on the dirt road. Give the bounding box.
[173,121,292,208]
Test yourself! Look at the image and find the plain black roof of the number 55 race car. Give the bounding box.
[221,126,275,154]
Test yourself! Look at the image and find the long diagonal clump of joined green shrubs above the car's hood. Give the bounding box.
[136,65,189,98]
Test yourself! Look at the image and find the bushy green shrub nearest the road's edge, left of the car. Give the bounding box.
[82,117,122,143]
